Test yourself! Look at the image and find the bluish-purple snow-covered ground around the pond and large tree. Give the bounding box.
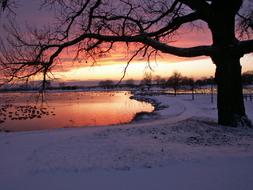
[0,95,253,190]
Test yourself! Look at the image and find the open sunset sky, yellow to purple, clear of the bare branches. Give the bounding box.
[1,0,253,80]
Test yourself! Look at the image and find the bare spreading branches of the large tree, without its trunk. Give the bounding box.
[0,0,253,85]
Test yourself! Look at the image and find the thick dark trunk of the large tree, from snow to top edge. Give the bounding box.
[208,0,251,127]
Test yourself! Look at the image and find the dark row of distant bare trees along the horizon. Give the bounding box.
[4,71,253,92]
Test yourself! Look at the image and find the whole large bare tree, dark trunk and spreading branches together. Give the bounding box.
[0,0,253,126]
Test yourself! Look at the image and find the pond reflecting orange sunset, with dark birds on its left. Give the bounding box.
[0,91,154,131]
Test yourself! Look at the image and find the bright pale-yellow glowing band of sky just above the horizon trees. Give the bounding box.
[55,55,253,80]
